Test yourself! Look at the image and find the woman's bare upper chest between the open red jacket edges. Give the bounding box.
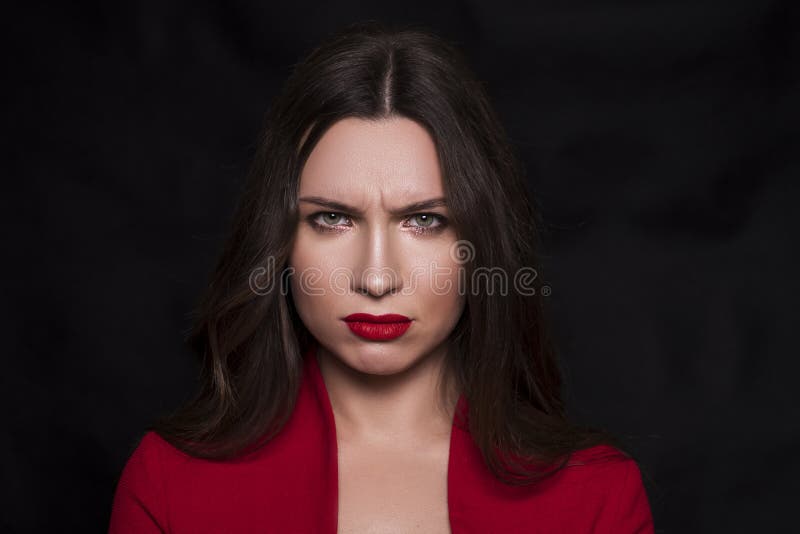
[338,444,450,534]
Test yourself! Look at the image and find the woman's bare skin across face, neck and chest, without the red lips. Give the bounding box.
[289,117,465,532]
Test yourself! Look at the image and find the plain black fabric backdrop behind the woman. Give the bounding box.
[7,0,800,533]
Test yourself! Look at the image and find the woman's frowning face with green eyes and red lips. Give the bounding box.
[289,117,464,375]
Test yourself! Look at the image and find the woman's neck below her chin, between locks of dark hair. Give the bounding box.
[317,344,458,447]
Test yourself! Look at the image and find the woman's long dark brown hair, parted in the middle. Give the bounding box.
[149,21,629,485]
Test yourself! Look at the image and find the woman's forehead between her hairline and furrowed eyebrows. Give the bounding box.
[300,117,442,199]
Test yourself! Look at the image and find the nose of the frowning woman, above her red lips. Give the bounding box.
[353,225,403,298]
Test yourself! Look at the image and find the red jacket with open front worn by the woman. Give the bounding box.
[109,347,653,534]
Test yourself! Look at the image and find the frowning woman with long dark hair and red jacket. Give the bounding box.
[110,23,653,533]
